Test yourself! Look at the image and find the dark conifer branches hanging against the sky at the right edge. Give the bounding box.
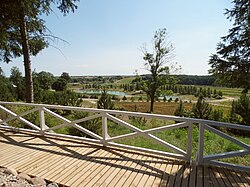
[209,0,250,93]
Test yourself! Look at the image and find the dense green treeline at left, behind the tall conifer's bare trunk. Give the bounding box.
[0,67,81,106]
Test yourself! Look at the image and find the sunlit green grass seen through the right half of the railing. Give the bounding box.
[108,119,250,166]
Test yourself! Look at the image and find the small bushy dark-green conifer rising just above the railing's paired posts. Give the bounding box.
[192,95,212,119]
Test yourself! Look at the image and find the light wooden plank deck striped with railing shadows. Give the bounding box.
[0,130,250,187]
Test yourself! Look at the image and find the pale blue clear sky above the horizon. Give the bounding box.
[1,0,232,76]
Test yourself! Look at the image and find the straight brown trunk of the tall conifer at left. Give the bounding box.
[20,5,34,103]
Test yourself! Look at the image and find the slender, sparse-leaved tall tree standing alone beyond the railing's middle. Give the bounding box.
[142,29,178,112]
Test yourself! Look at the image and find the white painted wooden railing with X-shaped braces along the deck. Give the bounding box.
[0,101,250,171]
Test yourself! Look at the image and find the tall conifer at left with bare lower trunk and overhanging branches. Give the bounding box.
[0,0,78,102]
